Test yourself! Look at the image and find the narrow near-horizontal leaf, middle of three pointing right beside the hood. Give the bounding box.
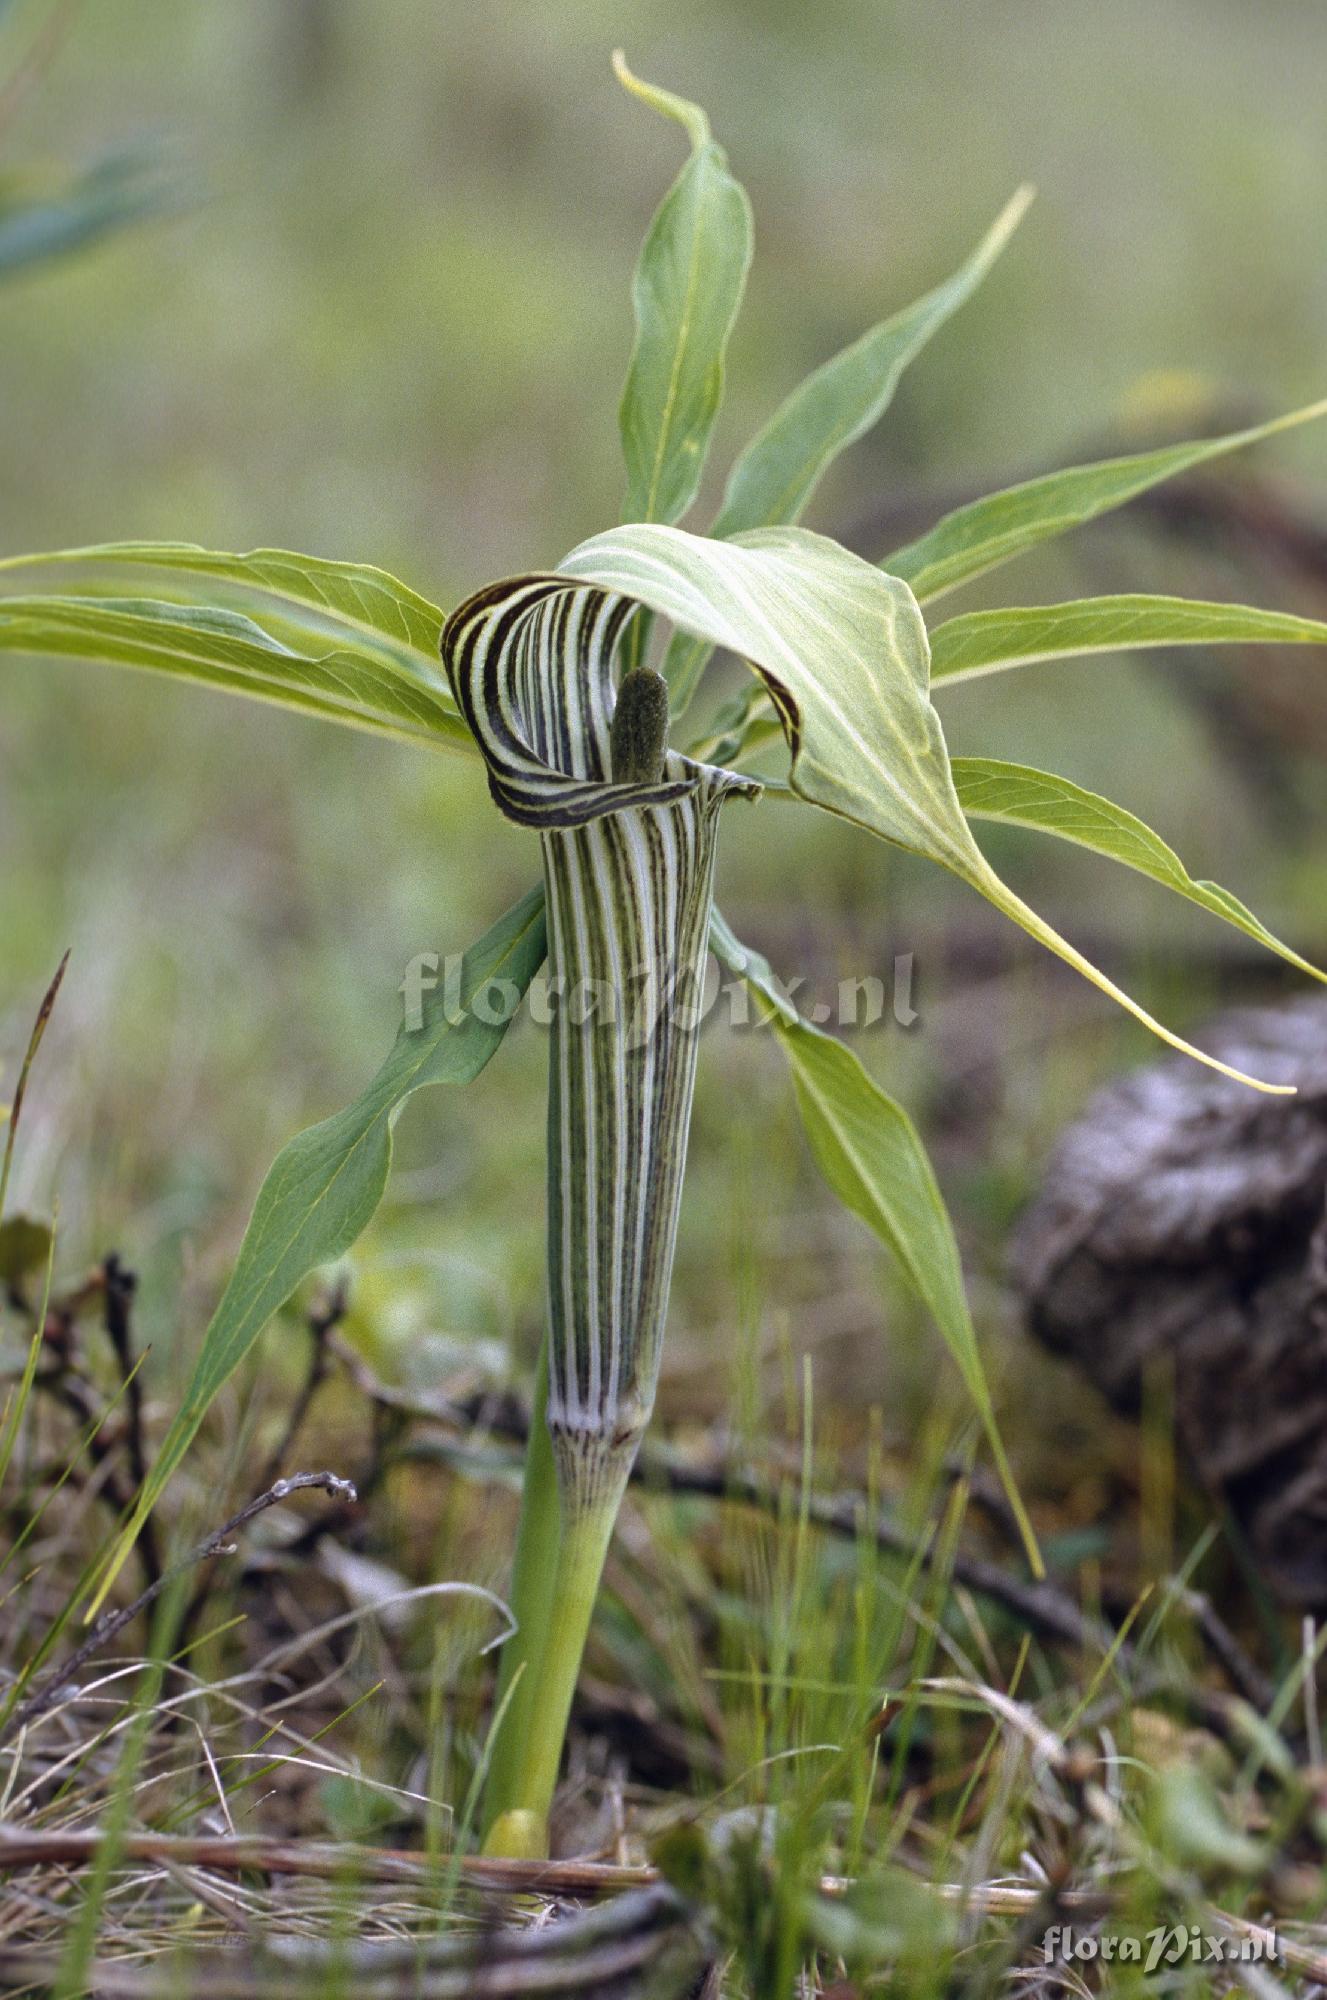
[931,596,1327,680]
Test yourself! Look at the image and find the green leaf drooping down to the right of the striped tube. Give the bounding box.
[709,910,1039,1572]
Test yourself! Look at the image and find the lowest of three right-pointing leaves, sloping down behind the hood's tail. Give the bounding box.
[953,758,1327,980]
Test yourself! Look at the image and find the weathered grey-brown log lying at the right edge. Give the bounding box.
[1011,998,1327,1606]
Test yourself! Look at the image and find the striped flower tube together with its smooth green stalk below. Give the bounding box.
[442,576,757,1854]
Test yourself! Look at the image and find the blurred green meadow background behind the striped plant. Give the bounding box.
[0,0,1327,1472]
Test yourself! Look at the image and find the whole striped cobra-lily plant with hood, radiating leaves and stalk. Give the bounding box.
[0,50,1327,1852]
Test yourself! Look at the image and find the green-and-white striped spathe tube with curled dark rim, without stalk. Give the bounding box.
[442,576,759,1506]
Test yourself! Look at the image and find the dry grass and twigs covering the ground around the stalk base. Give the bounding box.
[0,1232,1327,2000]
